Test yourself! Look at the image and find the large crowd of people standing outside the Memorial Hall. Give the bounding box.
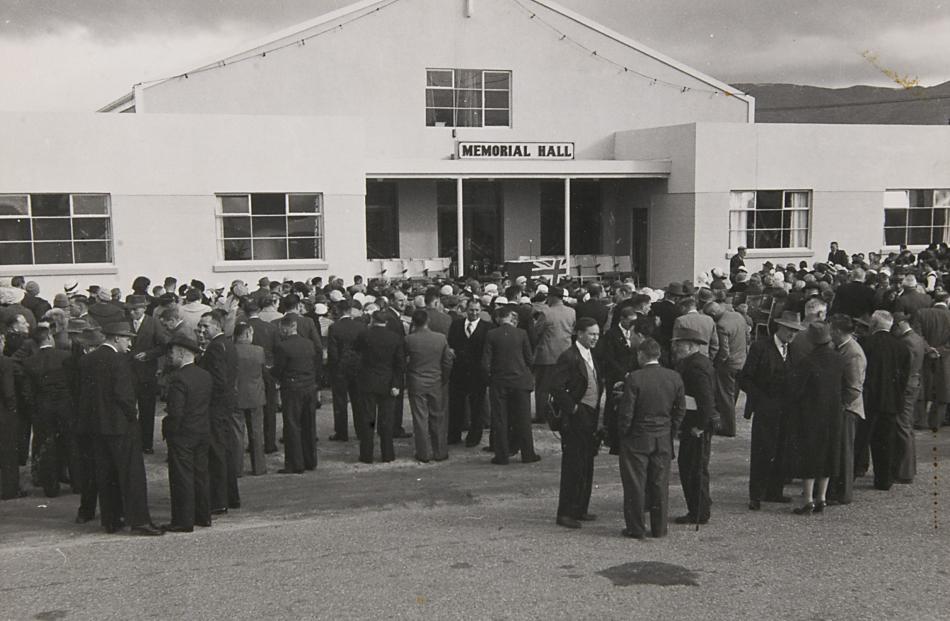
[0,244,950,538]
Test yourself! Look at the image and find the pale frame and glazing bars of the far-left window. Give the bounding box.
[0,192,115,269]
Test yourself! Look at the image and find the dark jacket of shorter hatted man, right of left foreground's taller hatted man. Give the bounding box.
[162,364,213,443]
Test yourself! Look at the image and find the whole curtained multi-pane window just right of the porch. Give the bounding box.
[729,190,811,249]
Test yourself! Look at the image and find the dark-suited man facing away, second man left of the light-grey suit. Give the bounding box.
[327,300,366,442]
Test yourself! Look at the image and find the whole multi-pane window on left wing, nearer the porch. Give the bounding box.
[218,193,323,261]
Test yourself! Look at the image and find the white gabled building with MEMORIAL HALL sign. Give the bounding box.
[0,0,950,292]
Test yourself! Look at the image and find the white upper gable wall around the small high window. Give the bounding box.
[139,0,748,162]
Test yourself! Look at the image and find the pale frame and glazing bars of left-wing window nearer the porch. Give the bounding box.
[215,191,327,265]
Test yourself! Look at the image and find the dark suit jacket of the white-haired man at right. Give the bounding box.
[861,330,910,414]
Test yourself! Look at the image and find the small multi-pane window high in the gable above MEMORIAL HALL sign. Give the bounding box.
[426,69,511,127]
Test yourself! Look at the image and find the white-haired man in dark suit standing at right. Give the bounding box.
[854,311,910,490]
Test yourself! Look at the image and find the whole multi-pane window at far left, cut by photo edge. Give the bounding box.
[0,194,112,265]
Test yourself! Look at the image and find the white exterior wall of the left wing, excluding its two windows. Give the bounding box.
[0,114,366,295]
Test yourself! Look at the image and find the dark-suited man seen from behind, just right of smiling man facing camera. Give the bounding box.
[481,306,540,465]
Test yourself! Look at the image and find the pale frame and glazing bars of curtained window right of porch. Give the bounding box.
[727,188,814,254]
